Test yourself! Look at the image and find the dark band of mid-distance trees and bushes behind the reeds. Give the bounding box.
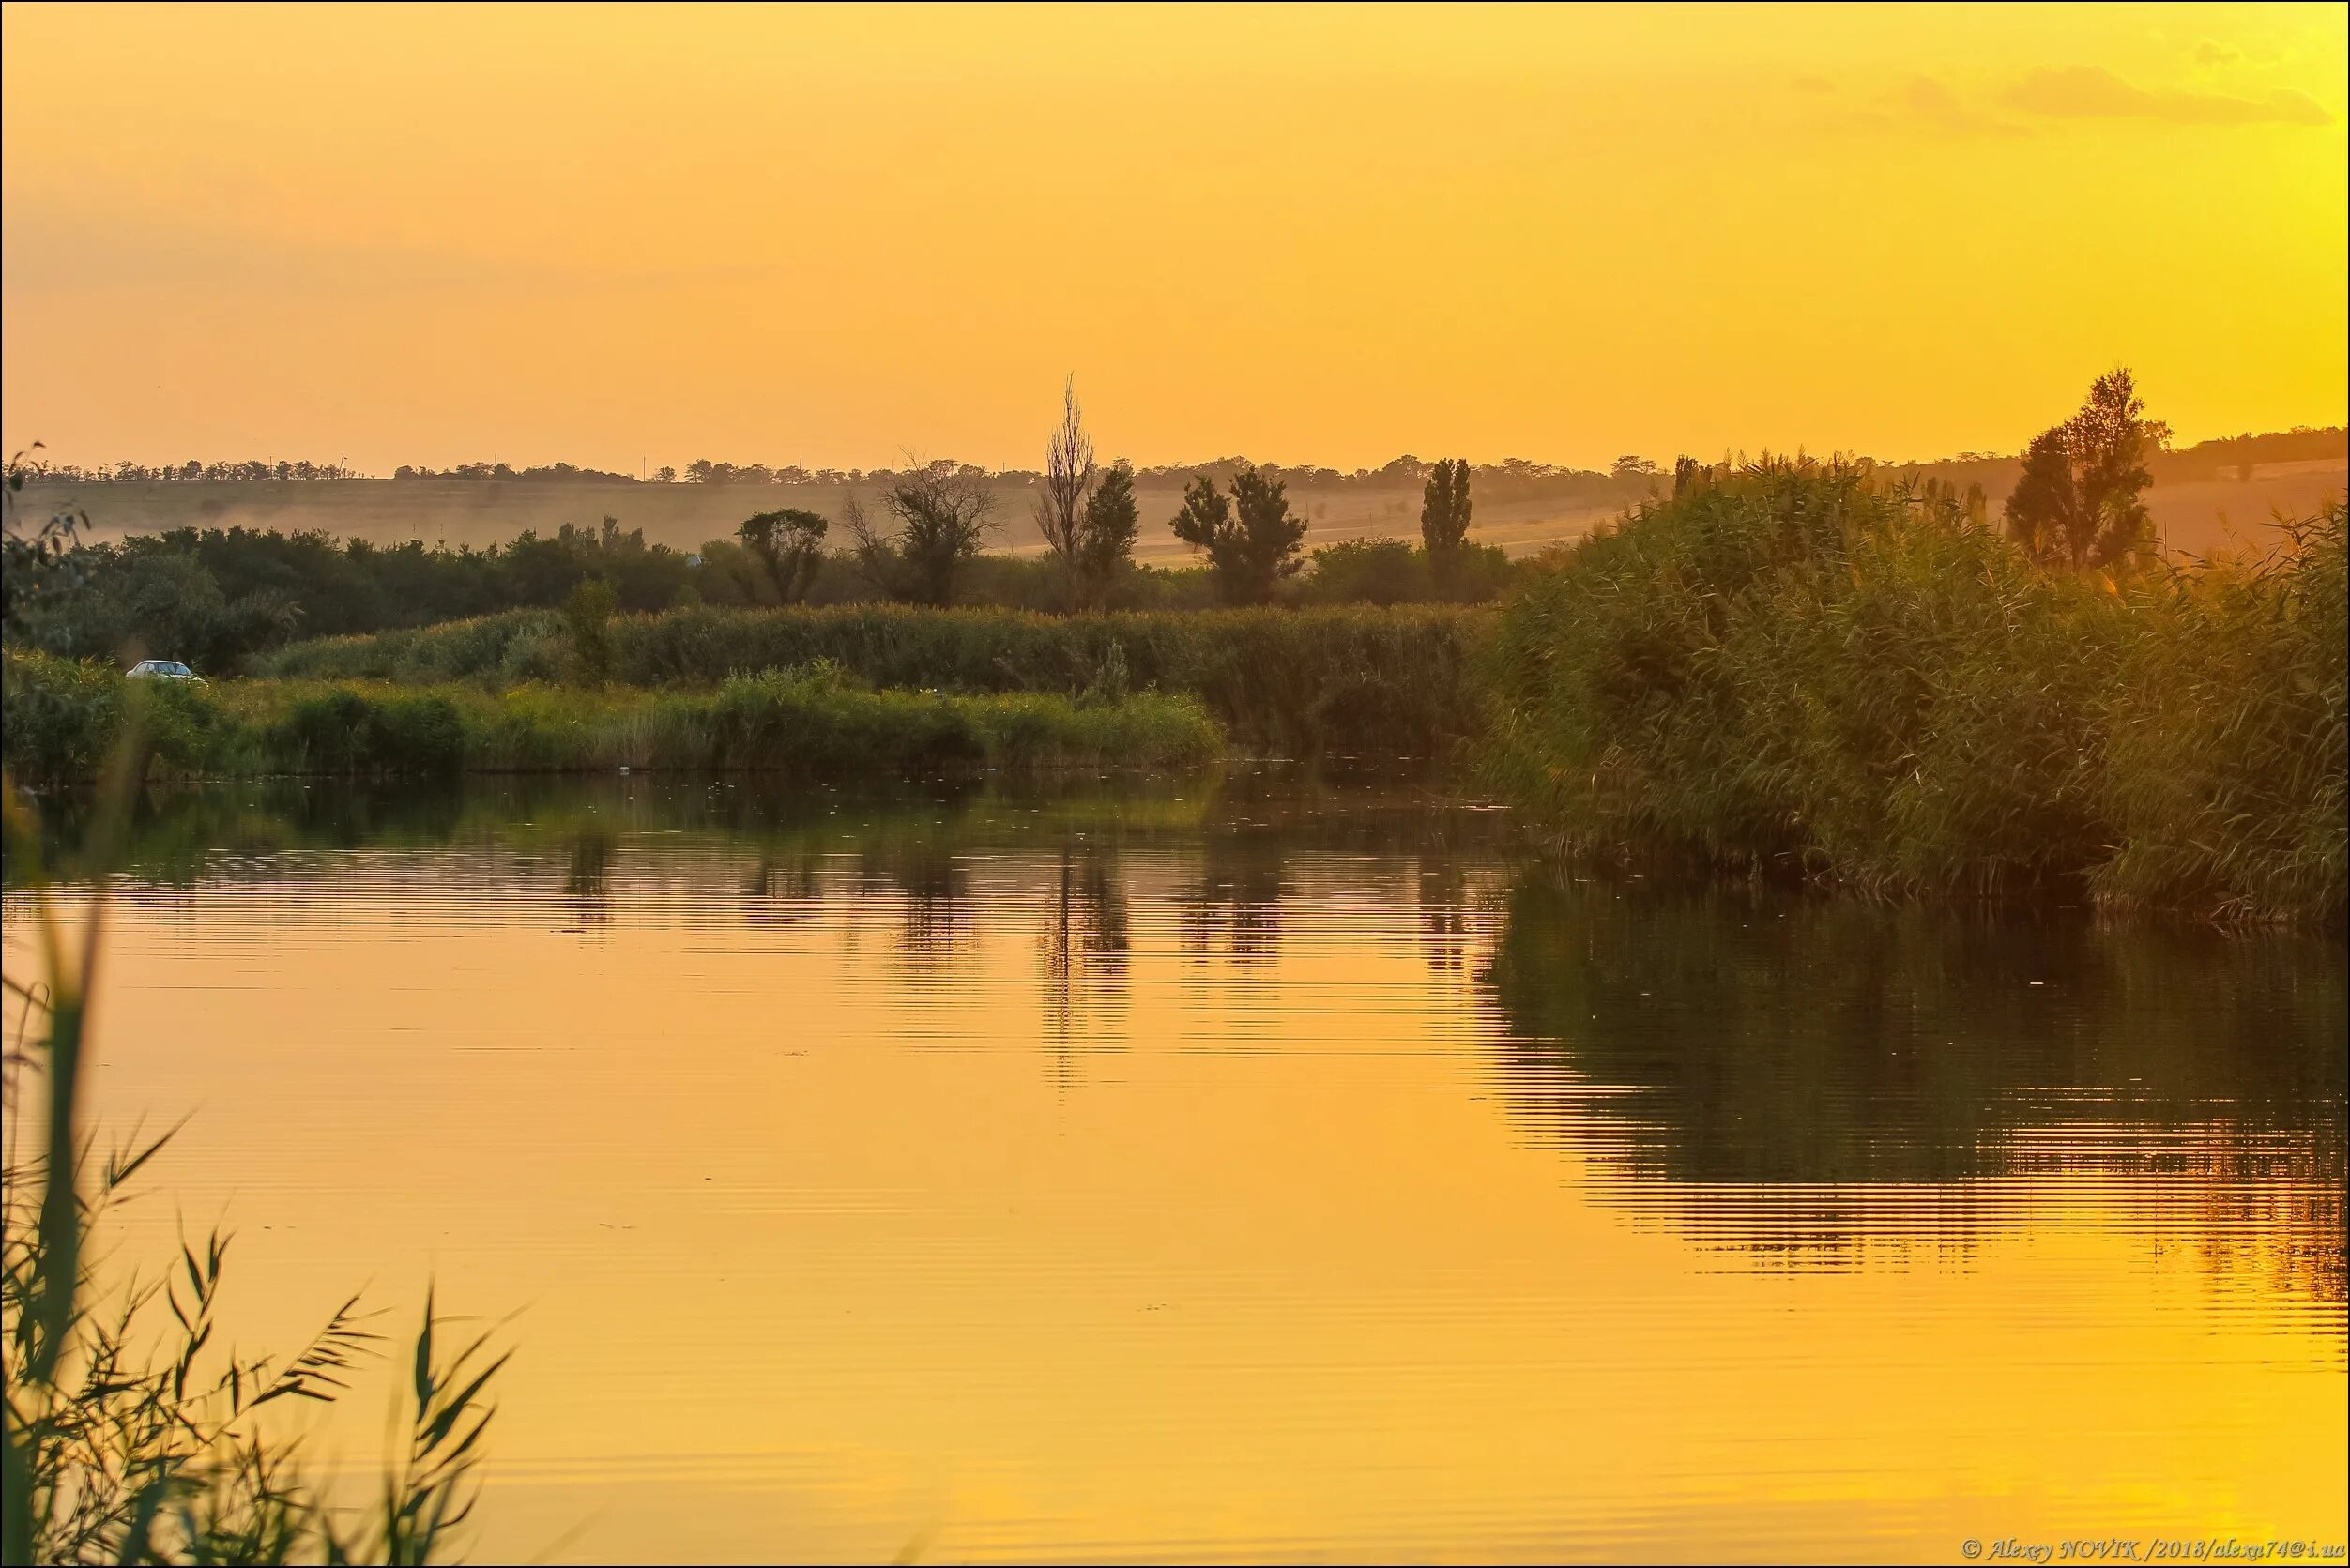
[0,383,1520,673]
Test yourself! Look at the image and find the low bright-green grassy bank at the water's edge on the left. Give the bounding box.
[5,653,1225,783]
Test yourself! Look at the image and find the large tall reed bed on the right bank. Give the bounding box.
[1481,464,2345,921]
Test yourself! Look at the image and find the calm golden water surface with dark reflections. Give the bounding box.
[8,776,2350,1560]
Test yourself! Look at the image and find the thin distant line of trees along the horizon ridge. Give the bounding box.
[23,425,2350,501]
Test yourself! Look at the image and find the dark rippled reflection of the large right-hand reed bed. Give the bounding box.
[1478,875,2345,1302]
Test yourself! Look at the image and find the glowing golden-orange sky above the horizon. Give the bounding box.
[0,5,2350,473]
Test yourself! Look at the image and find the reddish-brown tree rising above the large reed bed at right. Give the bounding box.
[2007,369,2169,571]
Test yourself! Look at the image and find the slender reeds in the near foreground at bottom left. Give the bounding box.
[0,698,512,1563]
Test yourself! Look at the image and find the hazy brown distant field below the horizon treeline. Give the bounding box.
[23,461,2350,562]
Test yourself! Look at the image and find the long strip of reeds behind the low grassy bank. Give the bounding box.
[243,604,1492,757]
